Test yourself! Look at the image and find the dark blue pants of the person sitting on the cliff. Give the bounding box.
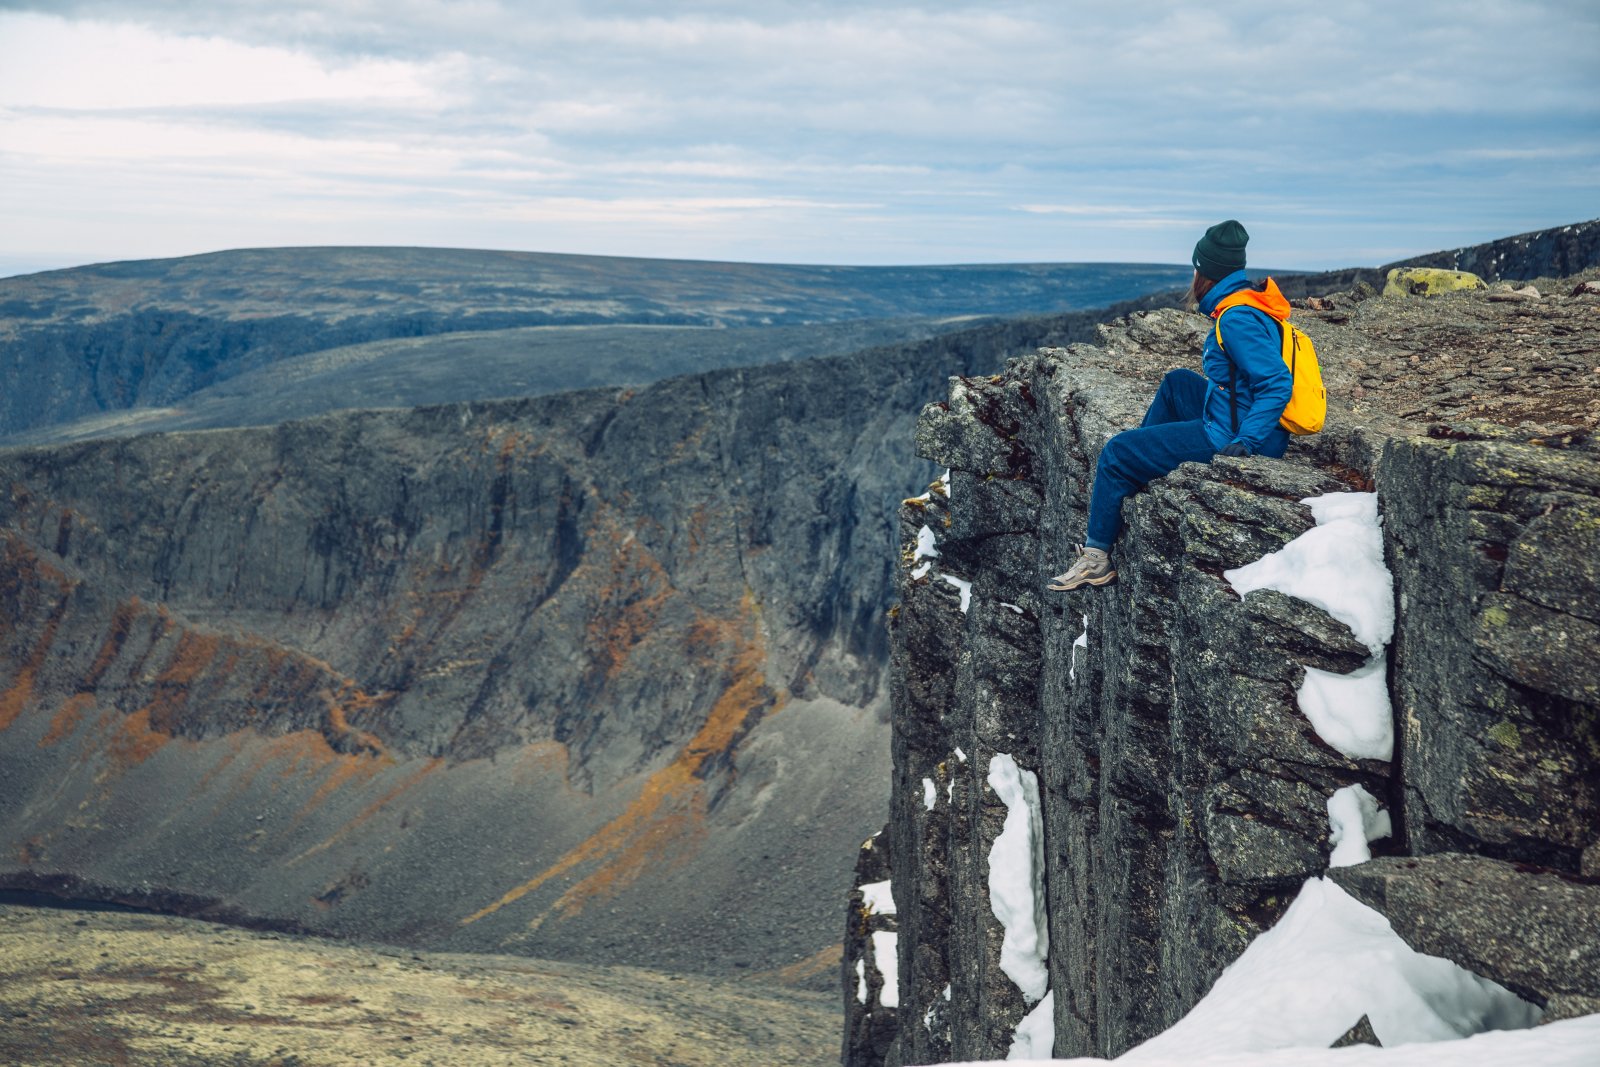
[1085,368,1216,550]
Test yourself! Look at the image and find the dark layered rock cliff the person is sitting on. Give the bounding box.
[845,273,1600,1064]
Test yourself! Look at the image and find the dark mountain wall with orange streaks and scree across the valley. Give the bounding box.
[0,326,1062,973]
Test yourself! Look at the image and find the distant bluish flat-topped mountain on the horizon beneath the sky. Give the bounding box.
[0,248,1187,443]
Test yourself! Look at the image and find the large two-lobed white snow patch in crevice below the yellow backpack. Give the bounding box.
[1222,493,1395,761]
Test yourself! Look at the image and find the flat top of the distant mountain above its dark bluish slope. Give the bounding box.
[0,248,1186,329]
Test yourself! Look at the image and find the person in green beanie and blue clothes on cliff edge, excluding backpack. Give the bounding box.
[1050,219,1294,590]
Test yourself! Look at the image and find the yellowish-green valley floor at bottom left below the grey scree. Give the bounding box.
[0,905,840,1067]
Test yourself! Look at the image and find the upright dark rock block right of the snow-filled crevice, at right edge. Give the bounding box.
[1379,434,1600,875]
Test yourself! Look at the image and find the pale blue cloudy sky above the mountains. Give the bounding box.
[0,0,1600,275]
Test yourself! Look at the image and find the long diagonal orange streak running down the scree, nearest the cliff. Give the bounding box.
[461,592,778,926]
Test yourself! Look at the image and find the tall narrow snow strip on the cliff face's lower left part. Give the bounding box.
[989,752,1050,1005]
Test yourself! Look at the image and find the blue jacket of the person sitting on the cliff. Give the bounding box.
[1200,270,1294,456]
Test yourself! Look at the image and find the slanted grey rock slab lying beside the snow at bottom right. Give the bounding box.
[1328,853,1600,1017]
